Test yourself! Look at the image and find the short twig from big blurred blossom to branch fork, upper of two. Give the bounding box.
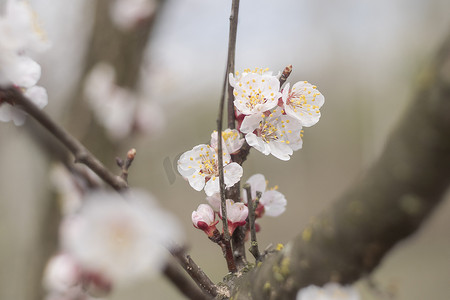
[172,248,217,297]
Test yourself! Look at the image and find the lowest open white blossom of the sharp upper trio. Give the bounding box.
[240,109,303,160]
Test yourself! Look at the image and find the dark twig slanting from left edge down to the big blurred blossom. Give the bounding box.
[0,87,128,191]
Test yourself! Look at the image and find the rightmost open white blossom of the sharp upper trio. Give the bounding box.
[282,81,325,127]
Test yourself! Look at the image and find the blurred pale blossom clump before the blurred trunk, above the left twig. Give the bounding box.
[84,63,166,140]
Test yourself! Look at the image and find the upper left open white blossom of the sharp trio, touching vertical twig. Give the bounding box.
[229,68,281,115]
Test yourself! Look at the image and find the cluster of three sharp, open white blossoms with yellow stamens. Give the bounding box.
[229,68,325,160]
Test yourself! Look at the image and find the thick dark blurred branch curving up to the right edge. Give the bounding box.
[233,32,450,299]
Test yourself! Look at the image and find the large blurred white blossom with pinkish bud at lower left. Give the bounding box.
[44,191,183,299]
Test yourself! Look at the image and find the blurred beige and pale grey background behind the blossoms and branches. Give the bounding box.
[0,0,450,300]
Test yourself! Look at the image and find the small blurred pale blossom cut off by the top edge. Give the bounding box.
[110,0,158,31]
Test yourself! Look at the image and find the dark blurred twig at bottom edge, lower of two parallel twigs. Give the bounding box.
[163,260,213,300]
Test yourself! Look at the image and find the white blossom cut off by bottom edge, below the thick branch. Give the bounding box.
[296,283,360,300]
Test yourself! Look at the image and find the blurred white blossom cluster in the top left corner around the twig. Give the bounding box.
[0,0,48,126]
